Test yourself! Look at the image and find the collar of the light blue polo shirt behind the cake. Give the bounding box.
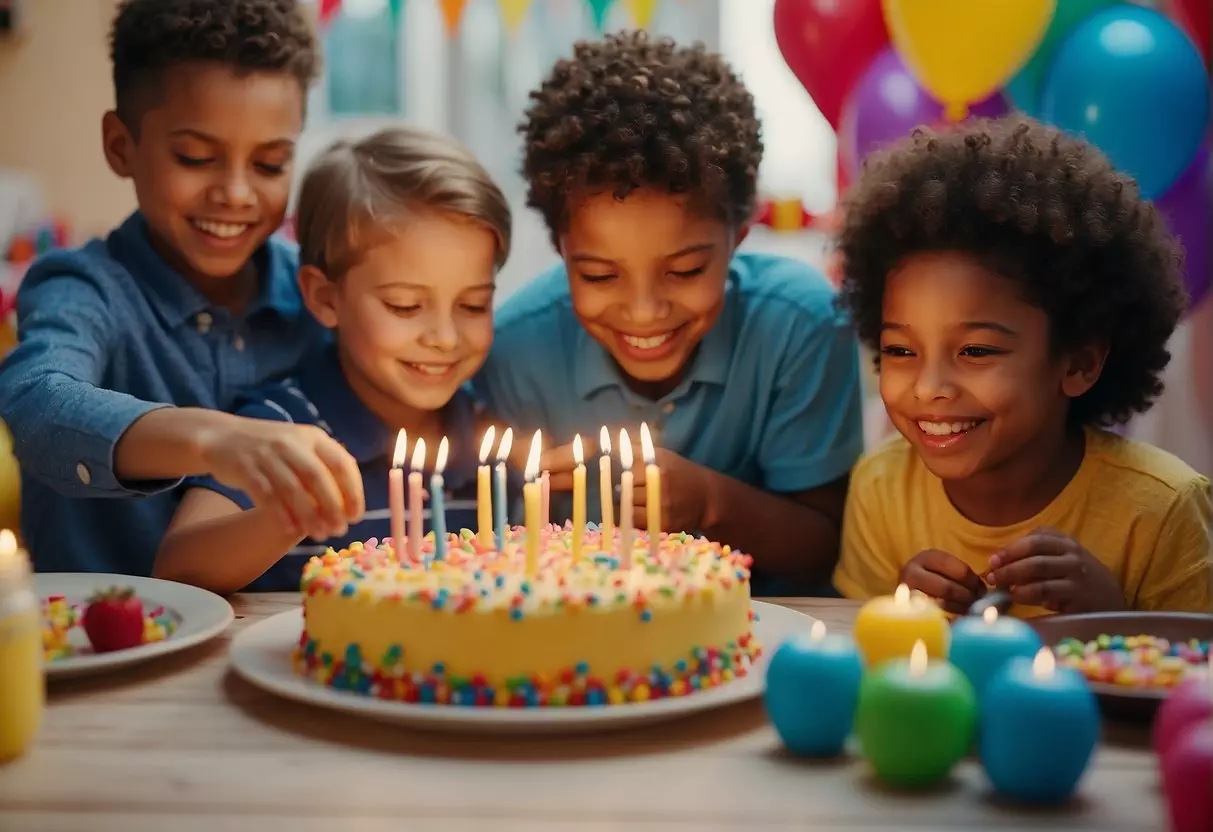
[574,267,736,399]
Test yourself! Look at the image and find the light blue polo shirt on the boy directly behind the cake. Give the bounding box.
[474,253,864,531]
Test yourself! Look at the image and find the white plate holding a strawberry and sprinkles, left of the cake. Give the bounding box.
[34,572,234,679]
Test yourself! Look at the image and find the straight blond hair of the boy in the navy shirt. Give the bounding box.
[295,127,511,279]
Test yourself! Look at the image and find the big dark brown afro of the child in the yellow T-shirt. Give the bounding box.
[838,116,1185,426]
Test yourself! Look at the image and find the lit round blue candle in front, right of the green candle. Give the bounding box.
[979,649,1099,804]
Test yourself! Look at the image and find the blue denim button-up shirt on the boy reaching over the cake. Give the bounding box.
[0,212,328,575]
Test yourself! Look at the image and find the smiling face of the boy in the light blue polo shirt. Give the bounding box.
[560,190,736,398]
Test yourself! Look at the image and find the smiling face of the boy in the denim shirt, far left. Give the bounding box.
[102,63,303,300]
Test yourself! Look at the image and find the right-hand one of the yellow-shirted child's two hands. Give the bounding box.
[986,529,1124,612]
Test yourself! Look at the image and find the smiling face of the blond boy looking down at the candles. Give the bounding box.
[300,211,497,424]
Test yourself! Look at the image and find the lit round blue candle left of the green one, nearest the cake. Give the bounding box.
[764,621,864,757]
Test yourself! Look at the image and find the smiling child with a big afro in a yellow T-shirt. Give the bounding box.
[835,118,1213,616]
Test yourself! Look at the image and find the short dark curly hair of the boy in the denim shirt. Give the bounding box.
[109,0,320,130]
